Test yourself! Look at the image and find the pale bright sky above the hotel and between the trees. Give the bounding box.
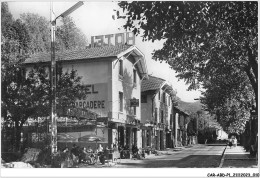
[8,1,201,102]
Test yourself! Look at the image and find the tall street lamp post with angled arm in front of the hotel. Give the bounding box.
[51,1,83,154]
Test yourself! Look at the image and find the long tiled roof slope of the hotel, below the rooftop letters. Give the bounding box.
[25,45,132,63]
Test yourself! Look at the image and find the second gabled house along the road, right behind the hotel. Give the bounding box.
[141,76,176,150]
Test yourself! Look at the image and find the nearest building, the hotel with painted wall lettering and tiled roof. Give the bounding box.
[25,45,147,147]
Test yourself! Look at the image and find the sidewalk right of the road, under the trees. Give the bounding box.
[220,146,257,168]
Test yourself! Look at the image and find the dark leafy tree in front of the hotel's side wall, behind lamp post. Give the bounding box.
[2,64,86,149]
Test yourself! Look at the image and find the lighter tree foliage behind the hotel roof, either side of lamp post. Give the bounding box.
[21,13,87,53]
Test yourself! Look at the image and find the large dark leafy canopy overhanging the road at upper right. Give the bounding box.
[118,1,258,108]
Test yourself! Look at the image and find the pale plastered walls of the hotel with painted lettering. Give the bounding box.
[63,51,142,147]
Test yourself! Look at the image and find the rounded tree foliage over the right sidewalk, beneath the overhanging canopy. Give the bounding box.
[202,69,254,133]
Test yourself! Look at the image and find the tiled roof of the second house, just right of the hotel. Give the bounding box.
[141,75,165,92]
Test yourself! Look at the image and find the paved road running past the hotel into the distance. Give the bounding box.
[112,145,225,168]
